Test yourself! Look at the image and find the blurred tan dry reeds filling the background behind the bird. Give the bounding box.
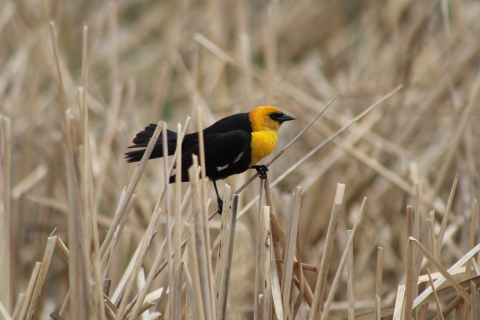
[0,0,480,319]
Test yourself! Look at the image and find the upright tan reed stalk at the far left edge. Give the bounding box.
[0,116,11,312]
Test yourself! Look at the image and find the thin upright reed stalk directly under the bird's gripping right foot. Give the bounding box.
[253,179,266,320]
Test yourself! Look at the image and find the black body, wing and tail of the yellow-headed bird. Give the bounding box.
[126,113,252,182]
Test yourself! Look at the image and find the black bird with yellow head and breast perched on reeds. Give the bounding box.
[125,106,295,214]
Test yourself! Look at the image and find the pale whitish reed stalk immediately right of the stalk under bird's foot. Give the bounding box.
[262,206,272,319]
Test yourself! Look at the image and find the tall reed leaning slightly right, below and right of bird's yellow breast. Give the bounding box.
[280,186,302,319]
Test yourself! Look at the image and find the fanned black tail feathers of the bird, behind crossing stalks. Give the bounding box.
[125,124,177,162]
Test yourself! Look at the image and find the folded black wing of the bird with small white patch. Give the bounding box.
[170,130,252,182]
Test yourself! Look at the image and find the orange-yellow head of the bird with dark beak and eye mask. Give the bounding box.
[248,106,295,132]
